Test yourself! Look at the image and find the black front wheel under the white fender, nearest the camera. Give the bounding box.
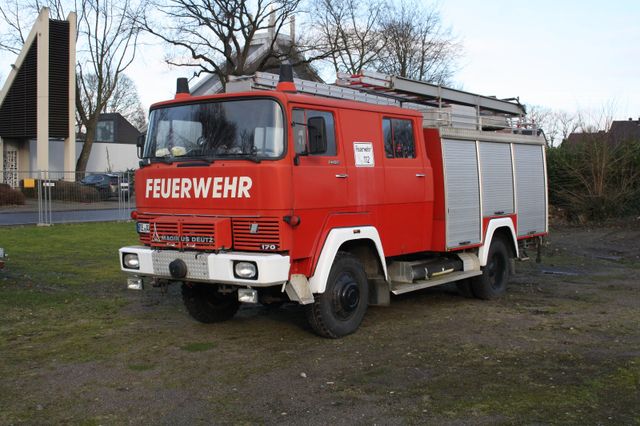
[307,252,369,339]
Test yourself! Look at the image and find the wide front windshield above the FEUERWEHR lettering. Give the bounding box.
[144,99,284,160]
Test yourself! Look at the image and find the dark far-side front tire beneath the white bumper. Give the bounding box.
[182,284,240,324]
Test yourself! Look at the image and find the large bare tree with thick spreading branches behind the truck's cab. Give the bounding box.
[139,0,320,87]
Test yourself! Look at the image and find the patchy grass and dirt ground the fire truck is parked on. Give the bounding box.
[0,223,640,425]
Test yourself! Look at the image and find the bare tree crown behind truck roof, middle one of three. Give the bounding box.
[313,0,386,74]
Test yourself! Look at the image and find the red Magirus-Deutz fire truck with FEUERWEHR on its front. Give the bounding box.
[120,66,548,338]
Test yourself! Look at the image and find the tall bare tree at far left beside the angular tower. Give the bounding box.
[0,0,140,172]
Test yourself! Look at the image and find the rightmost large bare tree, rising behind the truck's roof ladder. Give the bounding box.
[378,0,461,84]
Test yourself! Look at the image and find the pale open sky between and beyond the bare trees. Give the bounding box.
[0,0,640,124]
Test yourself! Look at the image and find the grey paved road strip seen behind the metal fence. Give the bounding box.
[0,209,129,226]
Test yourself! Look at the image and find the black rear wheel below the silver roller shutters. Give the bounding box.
[471,238,510,300]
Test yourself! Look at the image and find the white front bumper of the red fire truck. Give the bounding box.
[119,246,291,287]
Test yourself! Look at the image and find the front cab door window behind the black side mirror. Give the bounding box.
[293,108,336,156]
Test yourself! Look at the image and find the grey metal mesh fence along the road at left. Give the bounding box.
[0,171,135,225]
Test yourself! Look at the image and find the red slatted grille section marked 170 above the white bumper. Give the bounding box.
[231,218,281,251]
